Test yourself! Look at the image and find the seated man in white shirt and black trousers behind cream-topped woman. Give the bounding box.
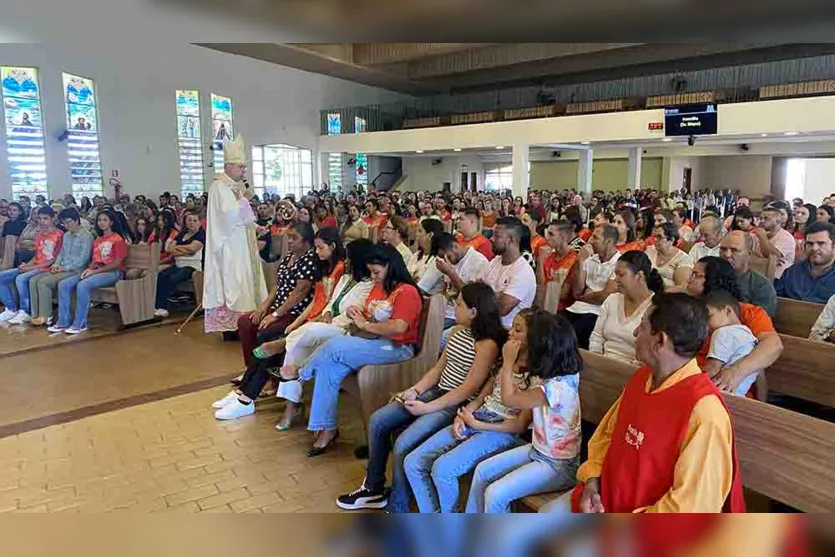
[563,224,620,350]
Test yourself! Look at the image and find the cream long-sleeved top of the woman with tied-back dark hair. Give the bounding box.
[589,292,652,364]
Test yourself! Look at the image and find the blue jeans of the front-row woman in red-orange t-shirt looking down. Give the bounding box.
[299,336,415,431]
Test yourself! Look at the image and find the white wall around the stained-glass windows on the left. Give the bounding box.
[0,44,406,197]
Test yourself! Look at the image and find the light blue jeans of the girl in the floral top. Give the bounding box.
[467,444,578,513]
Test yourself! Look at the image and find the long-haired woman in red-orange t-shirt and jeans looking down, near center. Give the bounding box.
[282,244,422,456]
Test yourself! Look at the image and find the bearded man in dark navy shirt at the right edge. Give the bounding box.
[774,222,835,304]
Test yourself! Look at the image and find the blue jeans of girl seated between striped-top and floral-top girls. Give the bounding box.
[404,426,519,513]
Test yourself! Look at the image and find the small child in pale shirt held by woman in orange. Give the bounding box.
[704,290,759,396]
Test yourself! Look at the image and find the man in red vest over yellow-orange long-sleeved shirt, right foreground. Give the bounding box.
[546,294,745,513]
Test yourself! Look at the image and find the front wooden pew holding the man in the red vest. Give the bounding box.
[519,351,835,512]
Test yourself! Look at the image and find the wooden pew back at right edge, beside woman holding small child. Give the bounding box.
[766,334,835,408]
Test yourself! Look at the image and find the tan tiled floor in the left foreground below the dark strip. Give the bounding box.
[0,387,365,513]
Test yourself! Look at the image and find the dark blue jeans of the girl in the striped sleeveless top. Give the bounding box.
[365,386,458,513]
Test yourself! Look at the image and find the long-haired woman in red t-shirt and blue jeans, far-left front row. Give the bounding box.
[47,209,128,335]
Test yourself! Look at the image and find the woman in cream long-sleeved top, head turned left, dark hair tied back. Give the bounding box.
[589,251,664,363]
